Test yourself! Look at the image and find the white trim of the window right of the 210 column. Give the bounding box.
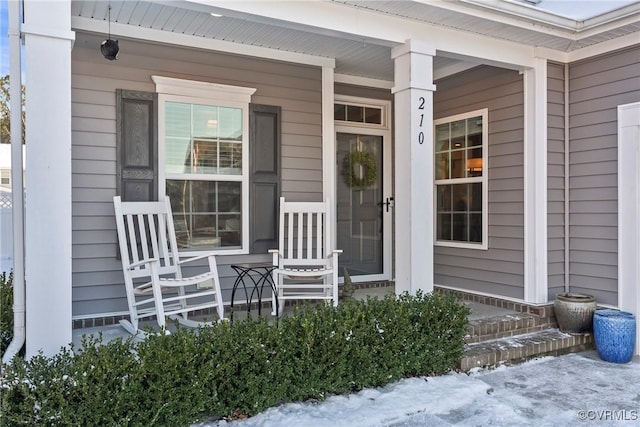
[433,108,489,250]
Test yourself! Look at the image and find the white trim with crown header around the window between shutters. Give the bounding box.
[151,76,256,256]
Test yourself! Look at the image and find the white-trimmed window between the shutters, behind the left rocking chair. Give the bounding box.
[154,76,254,253]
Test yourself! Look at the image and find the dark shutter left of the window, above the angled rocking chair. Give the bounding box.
[116,89,158,201]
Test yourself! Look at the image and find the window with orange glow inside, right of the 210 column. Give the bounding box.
[434,109,488,249]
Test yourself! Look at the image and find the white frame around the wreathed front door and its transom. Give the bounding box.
[333,95,394,282]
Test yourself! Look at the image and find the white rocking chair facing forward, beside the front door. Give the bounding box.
[269,197,342,316]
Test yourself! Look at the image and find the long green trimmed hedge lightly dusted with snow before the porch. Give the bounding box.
[0,293,469,426]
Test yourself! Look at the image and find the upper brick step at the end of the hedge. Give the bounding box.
[465,312,557,344]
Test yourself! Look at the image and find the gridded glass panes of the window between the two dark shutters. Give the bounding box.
[164,101,244,249]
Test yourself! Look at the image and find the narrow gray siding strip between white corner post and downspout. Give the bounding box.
[547,63,565,300]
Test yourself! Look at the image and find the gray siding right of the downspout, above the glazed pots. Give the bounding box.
[569,45,640,305]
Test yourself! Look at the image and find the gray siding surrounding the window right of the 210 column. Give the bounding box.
[434,67,524,298]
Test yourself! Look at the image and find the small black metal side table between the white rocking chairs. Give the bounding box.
[231,262,279,320]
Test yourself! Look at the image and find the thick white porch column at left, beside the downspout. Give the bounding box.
[22,0,74,357]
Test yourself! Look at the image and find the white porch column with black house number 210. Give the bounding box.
[391,40,435,294]
